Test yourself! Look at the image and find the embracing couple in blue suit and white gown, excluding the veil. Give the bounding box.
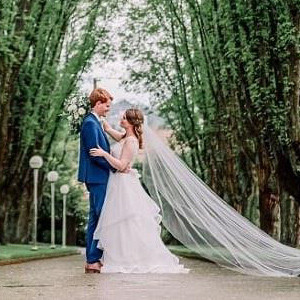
[78,88,188,273]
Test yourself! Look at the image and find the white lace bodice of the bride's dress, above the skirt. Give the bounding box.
[111,136,139,167]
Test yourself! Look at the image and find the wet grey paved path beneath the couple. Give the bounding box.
[0,255,300,300]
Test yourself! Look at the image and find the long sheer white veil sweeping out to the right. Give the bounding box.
[143,125,300,276]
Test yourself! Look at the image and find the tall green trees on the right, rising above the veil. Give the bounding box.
[121,0,300,244]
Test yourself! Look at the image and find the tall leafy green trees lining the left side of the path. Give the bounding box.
[0,0,114,243]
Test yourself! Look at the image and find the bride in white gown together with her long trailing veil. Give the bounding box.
[91,109,300,277]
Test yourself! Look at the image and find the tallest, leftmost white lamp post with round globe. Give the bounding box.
[29,155,43,250]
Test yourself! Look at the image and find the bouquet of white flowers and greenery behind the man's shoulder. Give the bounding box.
[62,92,90,134]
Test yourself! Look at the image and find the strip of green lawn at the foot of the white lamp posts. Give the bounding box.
[0,244,79,265]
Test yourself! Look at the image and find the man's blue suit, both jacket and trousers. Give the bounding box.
[78,113,114,264]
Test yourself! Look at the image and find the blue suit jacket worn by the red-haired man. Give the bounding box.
[78,113,114,184]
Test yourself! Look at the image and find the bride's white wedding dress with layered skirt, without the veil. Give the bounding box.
[94,137,189,273]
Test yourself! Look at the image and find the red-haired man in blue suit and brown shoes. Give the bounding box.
[78,88,114,273]
